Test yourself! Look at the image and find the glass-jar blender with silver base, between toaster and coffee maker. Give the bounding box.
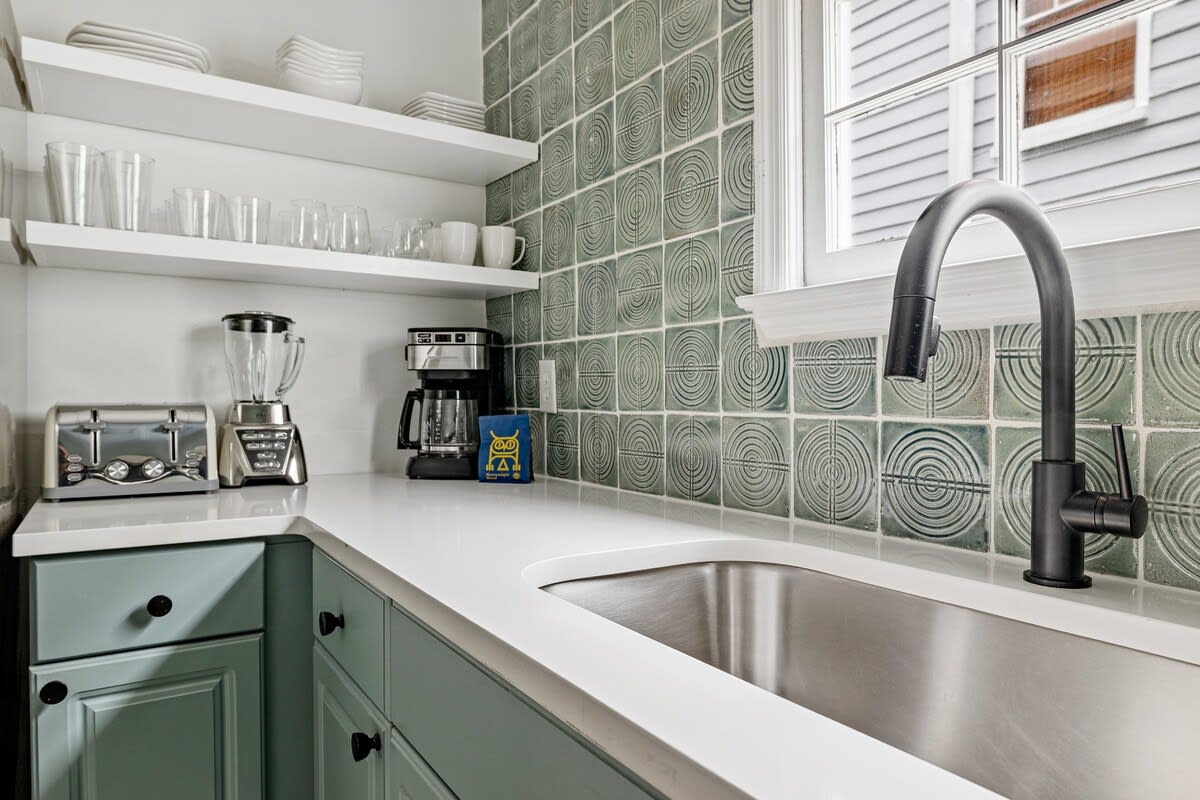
[217,311,308,487]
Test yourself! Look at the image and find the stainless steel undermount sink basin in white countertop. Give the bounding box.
[544,561,1200,800]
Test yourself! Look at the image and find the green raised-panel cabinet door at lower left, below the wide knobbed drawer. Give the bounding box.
[30,633,263,800]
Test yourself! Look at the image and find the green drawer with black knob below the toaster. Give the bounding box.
[30,541,263,662]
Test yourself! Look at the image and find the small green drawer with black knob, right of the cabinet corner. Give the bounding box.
[312,549,386,708]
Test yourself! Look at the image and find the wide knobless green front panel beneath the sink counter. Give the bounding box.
[389,608,652,800]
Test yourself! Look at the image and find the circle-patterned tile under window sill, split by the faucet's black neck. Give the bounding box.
[995,317,1138,423]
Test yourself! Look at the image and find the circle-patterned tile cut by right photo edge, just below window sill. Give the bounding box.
[1141,311,1200,428]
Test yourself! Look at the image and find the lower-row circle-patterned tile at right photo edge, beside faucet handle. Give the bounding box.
[1144,431,1200,589]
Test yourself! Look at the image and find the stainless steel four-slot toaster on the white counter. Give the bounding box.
[42,403,217,500]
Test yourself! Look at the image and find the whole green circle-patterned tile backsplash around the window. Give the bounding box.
[484,0,1200,590]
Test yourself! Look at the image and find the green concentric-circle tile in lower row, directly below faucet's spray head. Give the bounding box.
[880,422,991,552]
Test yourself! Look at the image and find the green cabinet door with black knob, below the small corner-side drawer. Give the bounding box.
[312,644,390,800]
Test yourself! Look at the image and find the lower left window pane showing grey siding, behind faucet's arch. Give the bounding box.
[829,70,997,248]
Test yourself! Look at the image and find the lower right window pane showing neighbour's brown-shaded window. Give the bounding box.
[1019,0,1200,205]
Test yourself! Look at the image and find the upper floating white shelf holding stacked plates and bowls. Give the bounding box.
[20,36,538,186]
